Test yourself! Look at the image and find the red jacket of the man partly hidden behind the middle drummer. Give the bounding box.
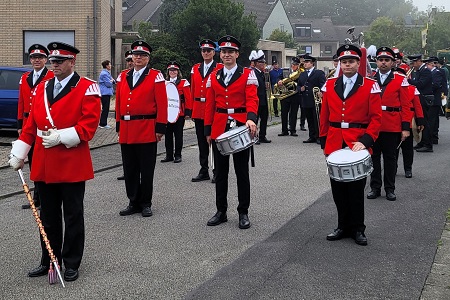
[186,61,223,120]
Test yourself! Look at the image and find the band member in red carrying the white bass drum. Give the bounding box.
[161,61,191,163]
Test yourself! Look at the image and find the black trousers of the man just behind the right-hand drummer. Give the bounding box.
[370,132,401,192]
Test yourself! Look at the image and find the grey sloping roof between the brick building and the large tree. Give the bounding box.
[122,0,163,25]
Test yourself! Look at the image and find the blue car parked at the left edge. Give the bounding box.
[0,67,31,129]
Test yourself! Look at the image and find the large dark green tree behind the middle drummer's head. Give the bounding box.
[171,0,260,65]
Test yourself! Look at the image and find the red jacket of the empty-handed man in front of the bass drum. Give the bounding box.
[116,67,168,144]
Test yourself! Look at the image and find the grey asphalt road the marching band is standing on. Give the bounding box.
[0,118,450,299]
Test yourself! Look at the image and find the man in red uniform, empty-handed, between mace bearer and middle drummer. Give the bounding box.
[116,41,167,217]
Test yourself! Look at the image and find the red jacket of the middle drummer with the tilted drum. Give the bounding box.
[205,66,258,139]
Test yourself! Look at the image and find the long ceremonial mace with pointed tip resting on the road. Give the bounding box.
[18,169,66,287]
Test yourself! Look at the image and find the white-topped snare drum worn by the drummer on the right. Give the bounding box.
[327,148,373,182]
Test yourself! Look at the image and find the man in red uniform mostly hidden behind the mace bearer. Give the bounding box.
[17,44,54,209]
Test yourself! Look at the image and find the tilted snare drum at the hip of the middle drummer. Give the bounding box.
[216,126,255,155]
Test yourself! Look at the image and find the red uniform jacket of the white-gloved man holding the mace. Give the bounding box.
[19,73,101,183]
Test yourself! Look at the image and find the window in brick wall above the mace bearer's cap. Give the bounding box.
[23,30,75,65]
